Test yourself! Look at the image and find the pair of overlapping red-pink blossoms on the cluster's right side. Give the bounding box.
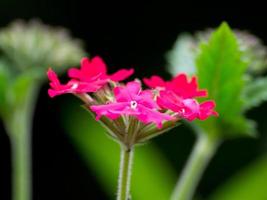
[144,74,218,121]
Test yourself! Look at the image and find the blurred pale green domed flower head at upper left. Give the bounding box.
[0,20,85,74]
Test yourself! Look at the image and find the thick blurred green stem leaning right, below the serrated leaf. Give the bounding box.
[171,134,219,200]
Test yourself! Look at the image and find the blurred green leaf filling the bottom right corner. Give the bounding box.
[209,156,267,200]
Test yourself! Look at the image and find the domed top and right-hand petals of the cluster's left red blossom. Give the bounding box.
[68,56,134,82]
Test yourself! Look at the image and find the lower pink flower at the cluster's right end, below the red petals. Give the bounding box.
[157,90,218,121]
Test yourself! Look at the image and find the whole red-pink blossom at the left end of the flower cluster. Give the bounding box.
[47,57,134,97]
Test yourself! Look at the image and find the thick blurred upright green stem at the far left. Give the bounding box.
[5,86,37,200]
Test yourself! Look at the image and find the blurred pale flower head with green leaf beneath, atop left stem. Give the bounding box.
[0,21,85,121]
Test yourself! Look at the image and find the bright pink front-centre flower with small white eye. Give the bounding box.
[90,81,173,128]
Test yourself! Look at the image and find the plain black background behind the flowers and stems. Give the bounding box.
[0,0,267,200]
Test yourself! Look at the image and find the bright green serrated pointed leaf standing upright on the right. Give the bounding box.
[196,23,254,138]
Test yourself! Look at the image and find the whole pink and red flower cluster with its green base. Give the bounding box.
[47,57,218,148]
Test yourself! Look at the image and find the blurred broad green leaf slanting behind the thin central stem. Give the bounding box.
[62,101,176,200]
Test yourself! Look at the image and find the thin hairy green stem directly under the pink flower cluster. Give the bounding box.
[117,146,134,200]
